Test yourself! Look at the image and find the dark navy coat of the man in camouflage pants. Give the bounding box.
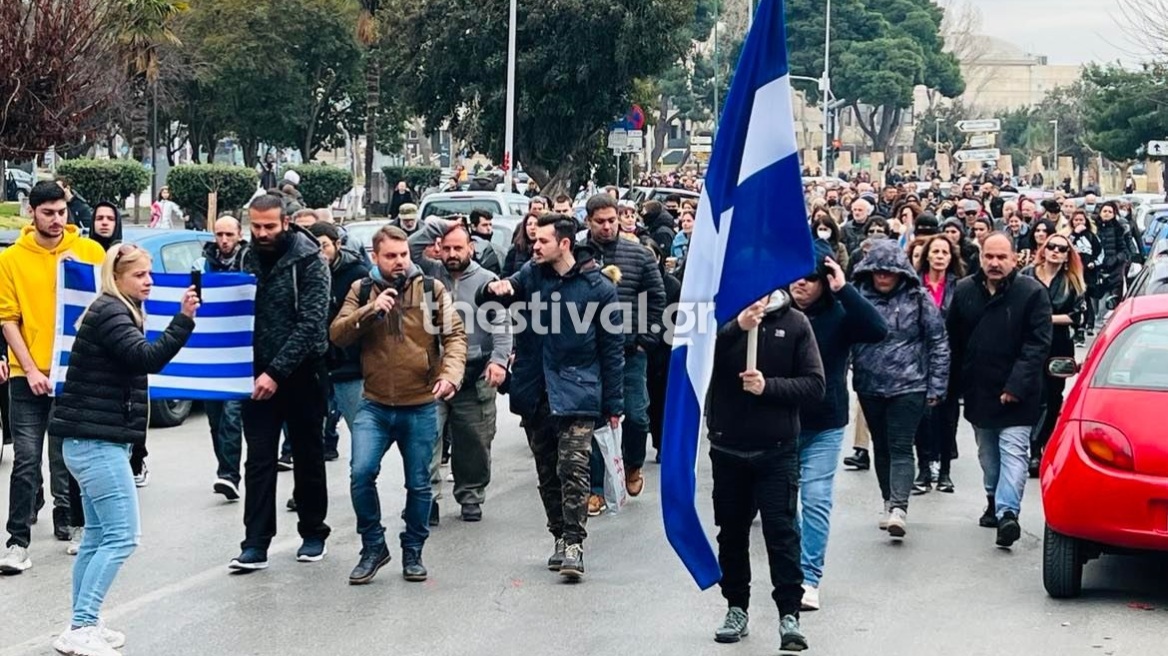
[475,247,625,419]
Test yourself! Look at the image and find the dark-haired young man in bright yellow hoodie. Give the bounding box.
[0,182,105,574]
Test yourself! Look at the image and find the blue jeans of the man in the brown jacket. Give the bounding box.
[349,399,438,549]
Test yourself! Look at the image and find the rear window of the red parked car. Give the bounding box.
[1091,319,1168,390]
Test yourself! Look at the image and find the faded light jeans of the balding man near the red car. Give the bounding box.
[973,426,1030,519]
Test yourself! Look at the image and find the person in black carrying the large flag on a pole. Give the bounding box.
[705,292,825,651]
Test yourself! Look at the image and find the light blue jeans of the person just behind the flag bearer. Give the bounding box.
[799,428,843,587]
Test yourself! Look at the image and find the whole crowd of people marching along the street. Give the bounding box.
[0,165,1140,656]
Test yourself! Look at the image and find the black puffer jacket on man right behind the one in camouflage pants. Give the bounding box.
[576,232,665,353]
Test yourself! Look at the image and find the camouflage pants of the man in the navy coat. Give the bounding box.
[524,412,596,544]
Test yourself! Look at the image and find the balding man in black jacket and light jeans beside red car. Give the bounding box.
[946,232,1052,547]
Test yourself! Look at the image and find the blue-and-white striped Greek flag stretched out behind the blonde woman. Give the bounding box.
[50,260,256,400]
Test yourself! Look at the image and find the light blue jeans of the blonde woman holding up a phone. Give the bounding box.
[62,438,141,627]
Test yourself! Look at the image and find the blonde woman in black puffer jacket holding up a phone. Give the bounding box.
[49,244,199,656]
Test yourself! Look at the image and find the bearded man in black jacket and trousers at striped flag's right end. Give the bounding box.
[230,194,329,572]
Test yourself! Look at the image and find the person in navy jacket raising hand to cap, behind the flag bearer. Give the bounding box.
[791,240,887,610]
